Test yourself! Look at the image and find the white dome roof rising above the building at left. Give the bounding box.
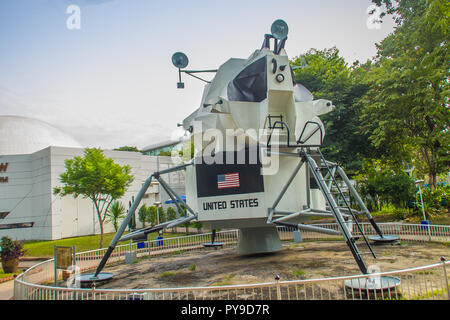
[0,116,82,155]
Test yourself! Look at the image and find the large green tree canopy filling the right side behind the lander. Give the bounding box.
[291,0,450,185]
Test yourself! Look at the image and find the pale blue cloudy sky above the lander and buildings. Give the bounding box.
[0,0,394,149]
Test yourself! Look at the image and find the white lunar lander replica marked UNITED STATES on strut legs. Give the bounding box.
[93,20,391,279]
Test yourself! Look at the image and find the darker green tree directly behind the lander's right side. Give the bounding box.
[291,47,374,172]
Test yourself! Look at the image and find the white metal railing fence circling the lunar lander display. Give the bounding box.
[14,223,450,300]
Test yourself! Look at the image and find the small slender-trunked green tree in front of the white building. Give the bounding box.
[53,148,134,248]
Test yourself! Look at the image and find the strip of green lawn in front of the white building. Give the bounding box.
[24,233,184,258]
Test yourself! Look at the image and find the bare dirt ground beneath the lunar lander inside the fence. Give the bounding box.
[99,241,450,289]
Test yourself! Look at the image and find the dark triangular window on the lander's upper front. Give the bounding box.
[227,57,267,102]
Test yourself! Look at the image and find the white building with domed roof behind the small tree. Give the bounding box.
[0,116,184,240]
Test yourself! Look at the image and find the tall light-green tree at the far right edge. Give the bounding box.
[361,0,450,186]
